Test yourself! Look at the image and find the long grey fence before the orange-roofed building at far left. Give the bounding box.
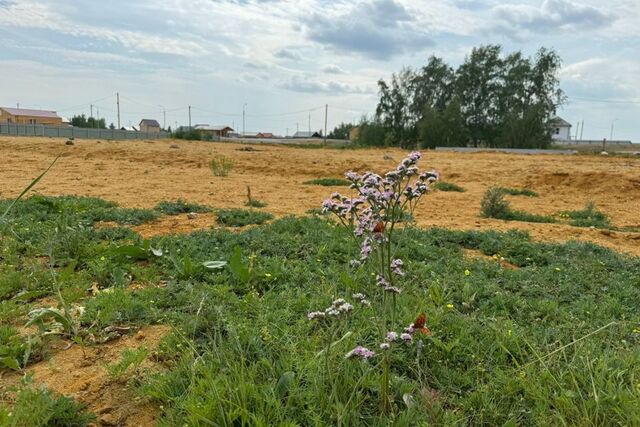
[0,123,169,139]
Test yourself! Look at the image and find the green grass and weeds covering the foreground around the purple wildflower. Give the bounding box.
[0,197,640,426]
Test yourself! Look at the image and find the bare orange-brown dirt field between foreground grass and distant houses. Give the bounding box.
[0,137,640,255]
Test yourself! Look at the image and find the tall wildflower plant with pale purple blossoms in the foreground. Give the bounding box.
[318,151,438,412]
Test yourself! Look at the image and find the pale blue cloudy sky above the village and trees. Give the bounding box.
[0,0,640,142]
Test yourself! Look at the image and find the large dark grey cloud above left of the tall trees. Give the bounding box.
[304,0,433,59]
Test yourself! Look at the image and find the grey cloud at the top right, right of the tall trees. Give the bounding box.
[493,0,614,38]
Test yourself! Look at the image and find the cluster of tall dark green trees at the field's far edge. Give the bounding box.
[329,45,565,148]
